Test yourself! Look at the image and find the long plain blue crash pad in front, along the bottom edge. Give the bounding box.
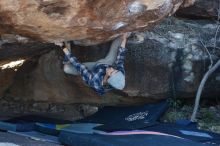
[59,131,210,146]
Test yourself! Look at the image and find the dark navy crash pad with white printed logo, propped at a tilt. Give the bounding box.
[77,101,168,132]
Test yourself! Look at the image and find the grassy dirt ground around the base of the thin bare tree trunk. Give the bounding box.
[161,99,220,133]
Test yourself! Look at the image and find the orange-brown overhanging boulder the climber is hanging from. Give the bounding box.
[0,0,195,45]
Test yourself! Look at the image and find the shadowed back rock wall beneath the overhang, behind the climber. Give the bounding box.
[2,18,220,105]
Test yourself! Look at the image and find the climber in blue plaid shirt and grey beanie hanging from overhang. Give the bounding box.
[59,33,129,95]
